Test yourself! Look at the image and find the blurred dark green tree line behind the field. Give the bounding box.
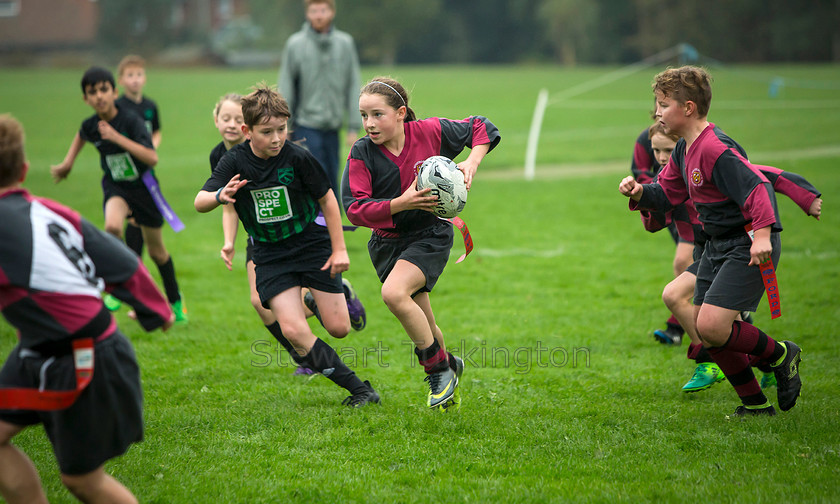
[100,0,840,65]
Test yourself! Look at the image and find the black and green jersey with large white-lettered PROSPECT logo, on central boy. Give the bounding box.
[202,140,330,243]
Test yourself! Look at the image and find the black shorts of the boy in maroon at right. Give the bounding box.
[694,233,782,312]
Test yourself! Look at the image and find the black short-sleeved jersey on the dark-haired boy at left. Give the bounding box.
[79,110,154,187]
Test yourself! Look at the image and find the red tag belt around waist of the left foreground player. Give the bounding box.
[0,338,93,411]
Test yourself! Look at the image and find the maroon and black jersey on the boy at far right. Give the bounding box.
[630,123,782,237]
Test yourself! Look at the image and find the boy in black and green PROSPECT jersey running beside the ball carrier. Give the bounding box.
[195,82,379,407]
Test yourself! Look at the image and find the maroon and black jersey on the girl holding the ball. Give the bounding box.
[342,116,502,236]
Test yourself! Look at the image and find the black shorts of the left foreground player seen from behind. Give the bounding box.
[0,330,143,475]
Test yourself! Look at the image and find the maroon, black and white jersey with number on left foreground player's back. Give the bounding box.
[0,189,172,348]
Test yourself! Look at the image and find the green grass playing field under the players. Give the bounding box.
[0,66,840,503]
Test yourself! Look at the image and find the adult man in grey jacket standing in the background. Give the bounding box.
[279,0,362,194]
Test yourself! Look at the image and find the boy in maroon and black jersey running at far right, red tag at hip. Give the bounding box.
[619,66,802,416]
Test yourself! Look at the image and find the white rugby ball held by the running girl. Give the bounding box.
[417,156,467,218]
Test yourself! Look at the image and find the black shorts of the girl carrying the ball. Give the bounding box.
[368,220,454,294]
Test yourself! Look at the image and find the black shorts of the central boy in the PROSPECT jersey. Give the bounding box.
[251,223,344,309]
